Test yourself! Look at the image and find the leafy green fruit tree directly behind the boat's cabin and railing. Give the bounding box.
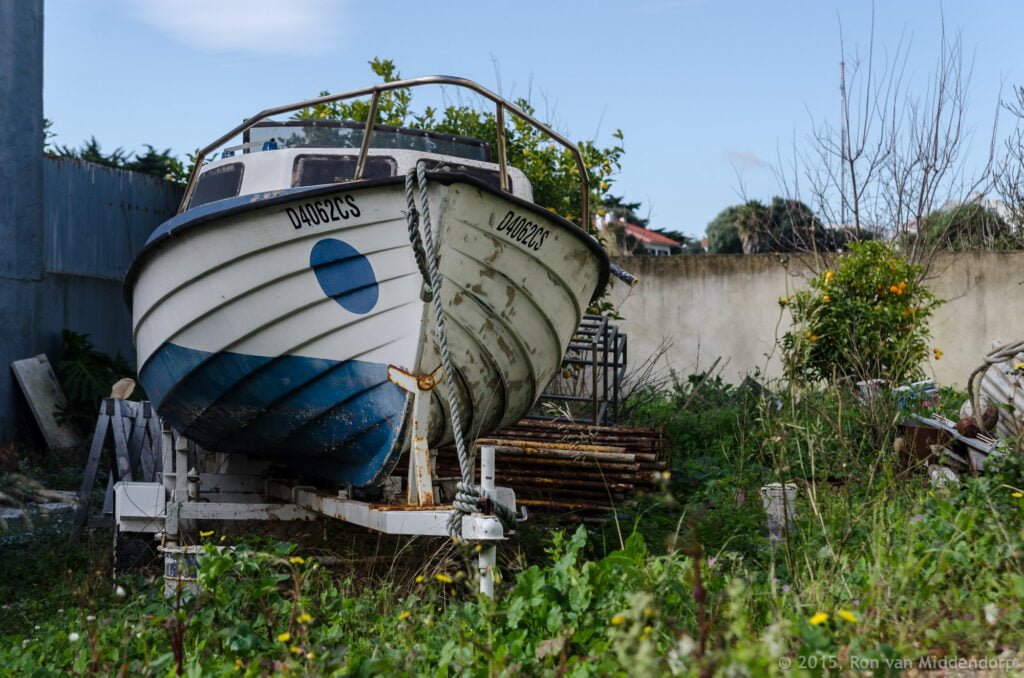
[295,58,625,229]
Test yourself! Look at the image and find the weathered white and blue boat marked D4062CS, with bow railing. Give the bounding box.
[125,76,609,485]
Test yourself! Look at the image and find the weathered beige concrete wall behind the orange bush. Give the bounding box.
[612,252,1024,388]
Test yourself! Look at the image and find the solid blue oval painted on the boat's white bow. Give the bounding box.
[309,238,380,313]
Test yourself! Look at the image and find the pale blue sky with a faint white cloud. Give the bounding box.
[44,0,1024,236]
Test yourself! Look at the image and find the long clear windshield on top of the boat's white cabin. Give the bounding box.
[239,120,490,162]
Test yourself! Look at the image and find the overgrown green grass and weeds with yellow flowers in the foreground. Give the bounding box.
[0,379,1024,676]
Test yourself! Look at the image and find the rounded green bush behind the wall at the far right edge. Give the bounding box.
[919,203,1024,251]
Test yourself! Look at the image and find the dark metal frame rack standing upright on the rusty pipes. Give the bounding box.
[529,314,627,424]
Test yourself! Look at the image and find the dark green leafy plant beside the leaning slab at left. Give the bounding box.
[55,330,145,431]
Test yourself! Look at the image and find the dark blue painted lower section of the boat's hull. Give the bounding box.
[139,343,408,486]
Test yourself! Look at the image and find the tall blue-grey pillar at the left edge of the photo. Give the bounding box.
[0,0,43,443]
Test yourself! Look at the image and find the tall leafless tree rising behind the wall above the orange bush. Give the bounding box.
[778,13,995,267]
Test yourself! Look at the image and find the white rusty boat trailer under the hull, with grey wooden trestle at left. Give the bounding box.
[73,389,515,596]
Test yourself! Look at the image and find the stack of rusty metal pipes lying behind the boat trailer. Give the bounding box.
[437,419,666,520]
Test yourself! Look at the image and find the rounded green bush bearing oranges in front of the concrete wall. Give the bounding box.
[779,242,942,383]
